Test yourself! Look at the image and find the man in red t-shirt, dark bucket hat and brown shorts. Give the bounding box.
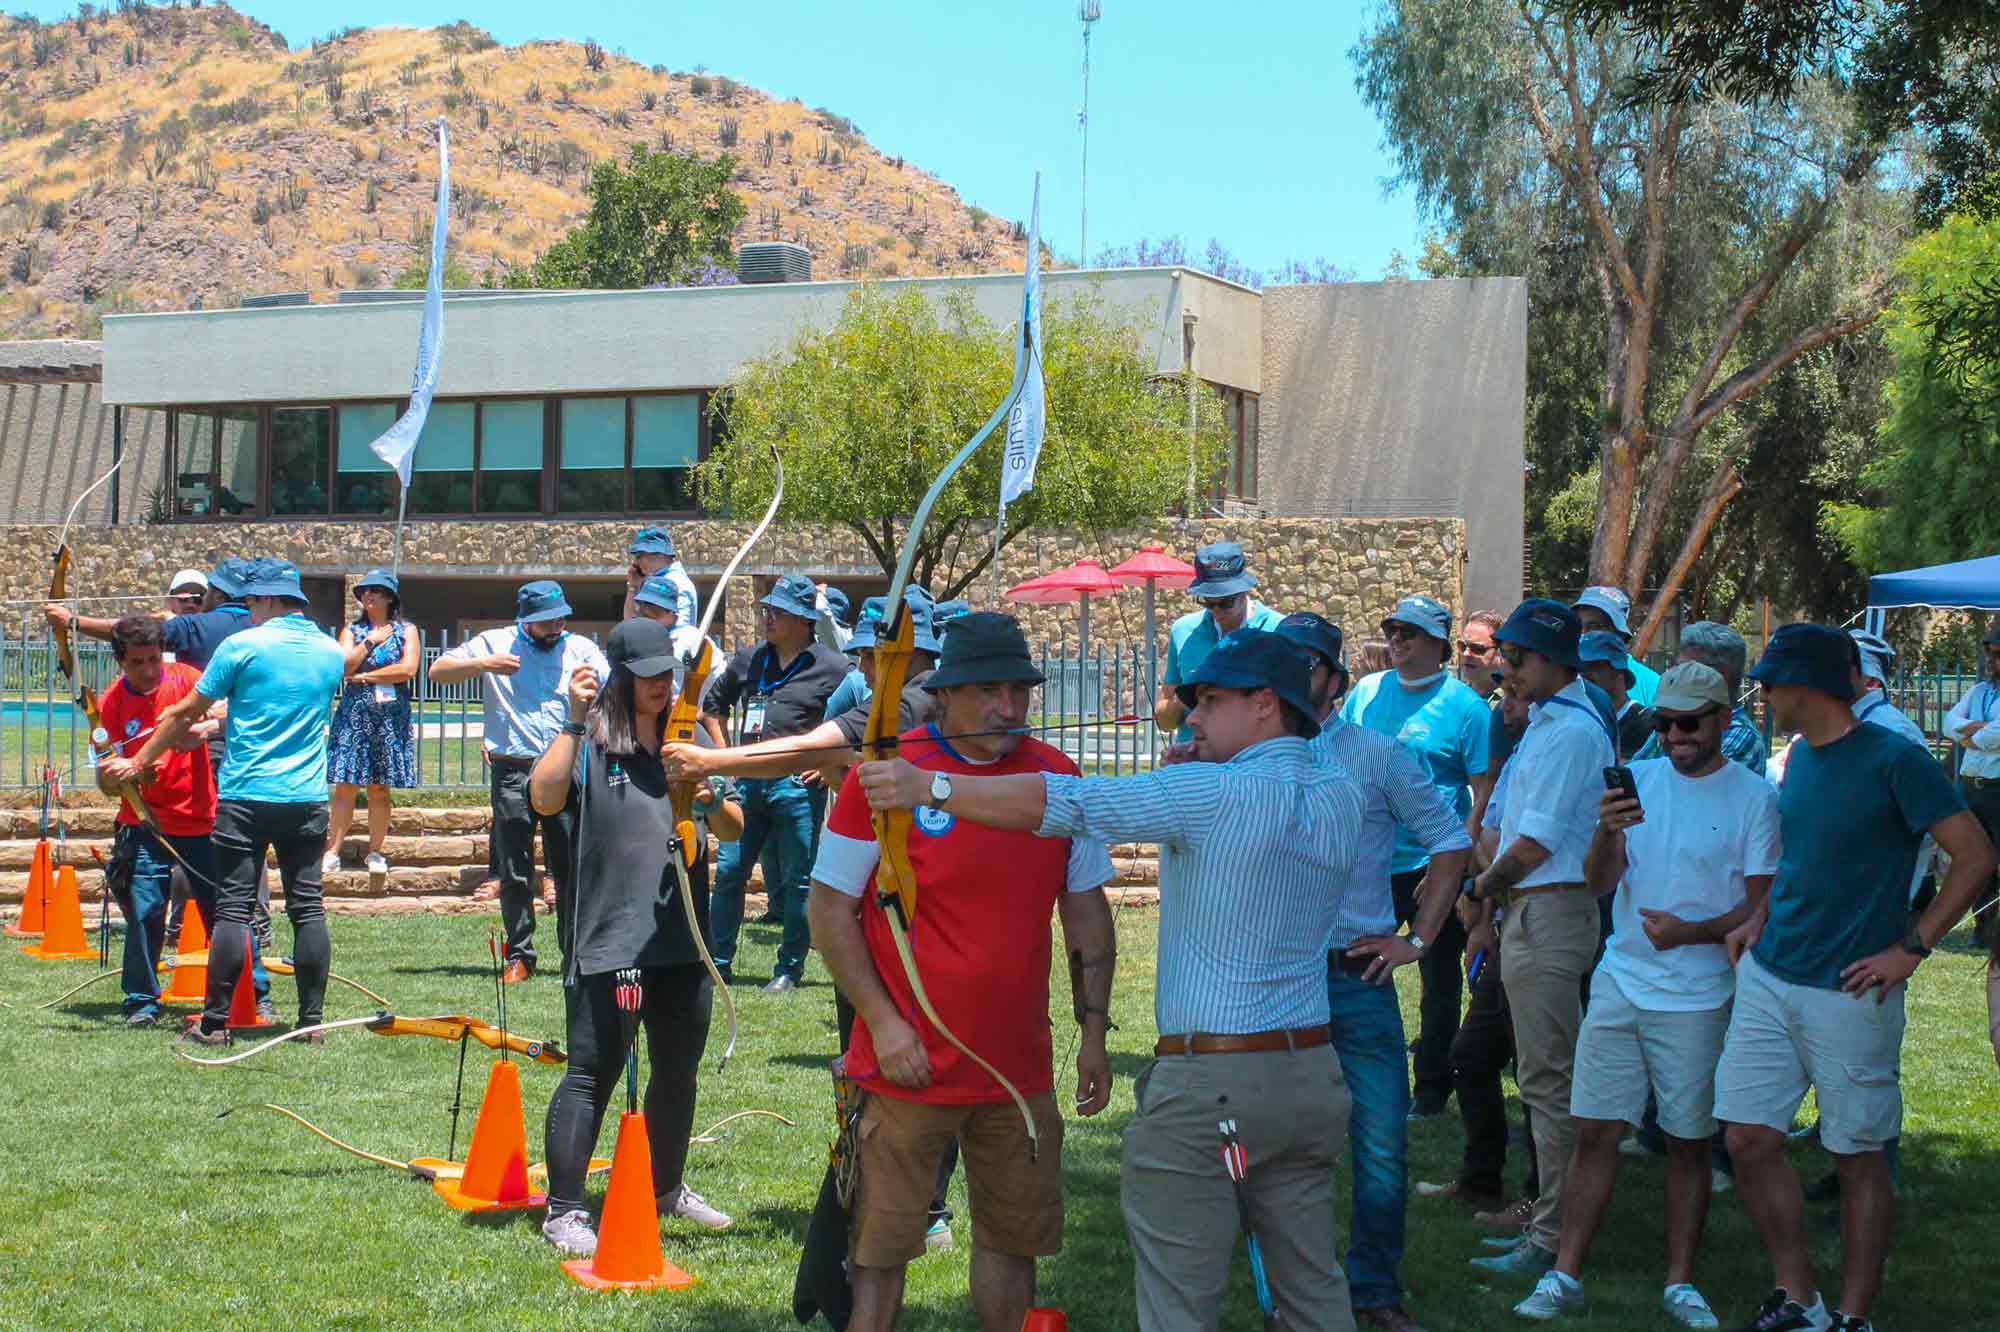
[810,612,1114,1332]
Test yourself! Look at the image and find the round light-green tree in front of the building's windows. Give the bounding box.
[696,284,1230,598]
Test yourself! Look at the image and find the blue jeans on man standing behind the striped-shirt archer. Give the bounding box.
[1326,960,1410,1308]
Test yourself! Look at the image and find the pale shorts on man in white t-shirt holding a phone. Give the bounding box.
[1570,966,1730,1140]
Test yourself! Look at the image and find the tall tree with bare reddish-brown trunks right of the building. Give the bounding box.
[1354,0,1886,646]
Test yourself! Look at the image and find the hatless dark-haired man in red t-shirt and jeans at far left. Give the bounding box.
[98,616,270,1026]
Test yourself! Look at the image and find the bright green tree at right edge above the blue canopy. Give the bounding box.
[1826,216,2000,570]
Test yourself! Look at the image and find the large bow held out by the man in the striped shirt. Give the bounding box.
[860,246,1040,1158]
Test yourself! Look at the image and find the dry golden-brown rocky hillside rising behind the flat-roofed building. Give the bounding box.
[0,0,1020,336]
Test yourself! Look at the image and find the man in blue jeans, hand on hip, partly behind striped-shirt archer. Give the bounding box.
[1278,610,1472,1332]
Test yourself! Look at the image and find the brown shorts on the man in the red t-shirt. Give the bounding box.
[852,1092,1062,1268]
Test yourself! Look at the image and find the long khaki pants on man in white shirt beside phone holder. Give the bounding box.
[1500,888,1598,1252]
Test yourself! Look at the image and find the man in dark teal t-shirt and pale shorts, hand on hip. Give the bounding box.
[1716,624,1994,1330]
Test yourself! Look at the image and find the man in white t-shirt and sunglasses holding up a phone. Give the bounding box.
[1514,660,1778,1328]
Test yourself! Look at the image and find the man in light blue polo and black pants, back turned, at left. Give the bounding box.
[108,560,346,1046]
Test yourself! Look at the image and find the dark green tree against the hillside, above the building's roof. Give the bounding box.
[534,144,746,288]
